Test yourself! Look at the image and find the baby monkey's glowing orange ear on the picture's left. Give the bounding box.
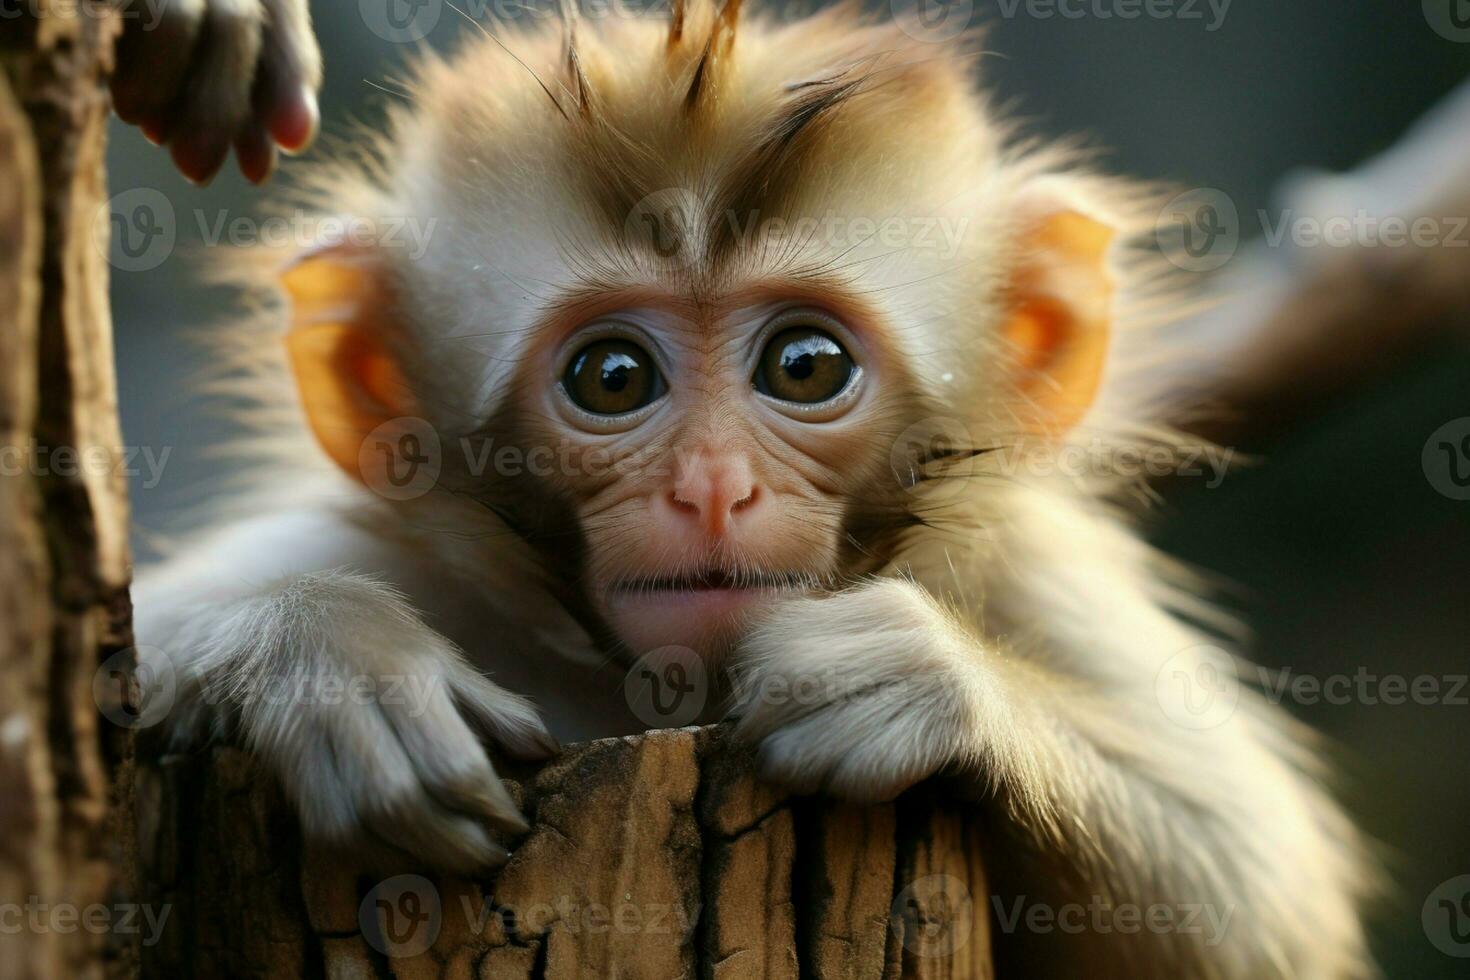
[281,247,415,479]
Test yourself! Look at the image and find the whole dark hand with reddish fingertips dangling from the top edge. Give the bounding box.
[112,0,322,184]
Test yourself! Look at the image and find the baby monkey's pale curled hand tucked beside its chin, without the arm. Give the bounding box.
[731,580,983,801]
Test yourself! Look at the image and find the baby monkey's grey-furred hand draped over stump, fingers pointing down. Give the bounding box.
[140,572,557,873]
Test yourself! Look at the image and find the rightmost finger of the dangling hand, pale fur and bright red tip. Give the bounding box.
[251,0,322,153]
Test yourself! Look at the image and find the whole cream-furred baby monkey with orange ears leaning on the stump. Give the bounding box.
[123,0,1372,980]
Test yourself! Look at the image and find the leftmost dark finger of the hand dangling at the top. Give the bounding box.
[112,0,204,134]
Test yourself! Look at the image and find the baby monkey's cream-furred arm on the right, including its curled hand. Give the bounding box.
[735,580,1360,979]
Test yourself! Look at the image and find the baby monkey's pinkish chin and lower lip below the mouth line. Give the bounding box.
[607,588,781,660]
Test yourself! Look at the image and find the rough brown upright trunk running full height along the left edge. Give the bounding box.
[0,0,129,977]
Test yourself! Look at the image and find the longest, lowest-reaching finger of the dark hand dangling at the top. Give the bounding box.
[169,0,262,184]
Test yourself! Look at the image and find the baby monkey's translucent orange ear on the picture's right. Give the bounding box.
[1005,181,1113,433]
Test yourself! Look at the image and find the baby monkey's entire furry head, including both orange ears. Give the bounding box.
[277,3,1113,667]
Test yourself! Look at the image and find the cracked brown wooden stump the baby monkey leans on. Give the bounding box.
[138,729,992,980]
